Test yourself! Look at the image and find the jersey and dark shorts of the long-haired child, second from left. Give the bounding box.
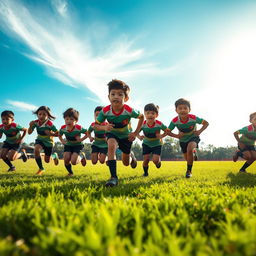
[31,120,57,156]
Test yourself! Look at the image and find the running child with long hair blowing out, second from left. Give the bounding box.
[28,106,59,175]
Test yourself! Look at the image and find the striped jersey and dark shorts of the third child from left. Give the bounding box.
[59,124,87,154]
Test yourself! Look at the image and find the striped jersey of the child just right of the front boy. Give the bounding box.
[141,120,167,147]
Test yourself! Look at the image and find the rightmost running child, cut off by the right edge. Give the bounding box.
[233,112,256,172]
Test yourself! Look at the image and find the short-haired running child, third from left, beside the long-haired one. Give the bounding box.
[59,108,87,176]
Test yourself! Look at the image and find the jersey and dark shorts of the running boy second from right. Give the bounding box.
[168,114,205,154]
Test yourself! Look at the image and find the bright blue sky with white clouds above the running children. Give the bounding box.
[0,0,256,146]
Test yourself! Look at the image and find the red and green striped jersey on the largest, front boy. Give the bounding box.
[96,104,141,139]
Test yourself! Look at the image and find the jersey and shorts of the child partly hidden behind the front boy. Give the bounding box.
[88,122,108,155]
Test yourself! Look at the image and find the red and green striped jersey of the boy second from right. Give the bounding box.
[168,114,204,142]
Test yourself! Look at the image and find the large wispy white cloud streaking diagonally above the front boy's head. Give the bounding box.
[0,0,177,104]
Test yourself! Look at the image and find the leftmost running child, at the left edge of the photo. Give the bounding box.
[0,110,27,172]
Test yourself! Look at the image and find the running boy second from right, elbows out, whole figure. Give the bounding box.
[168,98,209,178]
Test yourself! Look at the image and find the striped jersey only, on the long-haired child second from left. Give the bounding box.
[32,120,57,147]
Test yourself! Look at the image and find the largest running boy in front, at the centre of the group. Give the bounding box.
[95,80,144,186]
